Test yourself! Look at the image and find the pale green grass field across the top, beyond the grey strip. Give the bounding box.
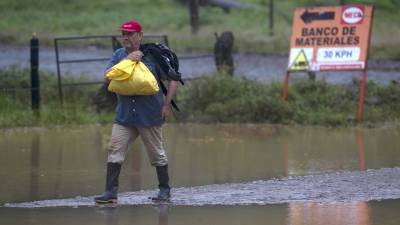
[0,0,400,59]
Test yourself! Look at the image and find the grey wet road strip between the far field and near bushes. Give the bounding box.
[0,46,400,84]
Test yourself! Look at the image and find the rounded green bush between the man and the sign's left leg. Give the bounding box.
[178,74,290,122]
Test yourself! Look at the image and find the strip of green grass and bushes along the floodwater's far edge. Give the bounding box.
[0,69,400,127]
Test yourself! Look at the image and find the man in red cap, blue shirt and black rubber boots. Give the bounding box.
[95,20,180,204]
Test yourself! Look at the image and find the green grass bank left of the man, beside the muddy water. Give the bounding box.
[0,68,113,127]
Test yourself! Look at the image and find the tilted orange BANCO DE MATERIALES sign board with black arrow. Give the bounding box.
[288,5,373,71]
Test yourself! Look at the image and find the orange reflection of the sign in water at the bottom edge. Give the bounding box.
[286,202,370,225]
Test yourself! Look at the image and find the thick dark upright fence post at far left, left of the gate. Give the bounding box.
[31,33,40,115]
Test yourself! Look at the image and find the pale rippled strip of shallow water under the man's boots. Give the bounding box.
[5,168,400,208]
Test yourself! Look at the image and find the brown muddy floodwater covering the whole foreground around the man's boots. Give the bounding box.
[0,124,400,225]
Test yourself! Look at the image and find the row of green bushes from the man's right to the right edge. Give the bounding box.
[178,74,400,126]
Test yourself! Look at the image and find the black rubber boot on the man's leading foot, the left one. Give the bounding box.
[94,163,121,204]
